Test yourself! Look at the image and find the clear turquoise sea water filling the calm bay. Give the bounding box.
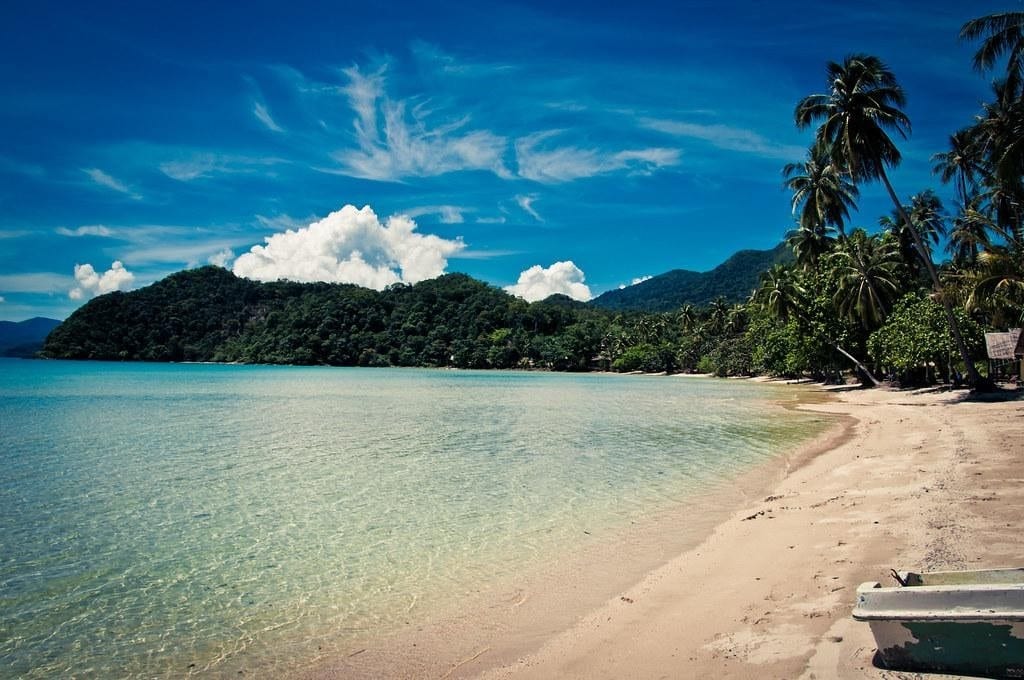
[0,360,824,678]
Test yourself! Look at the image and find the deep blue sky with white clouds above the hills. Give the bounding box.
[0,0,1022,321]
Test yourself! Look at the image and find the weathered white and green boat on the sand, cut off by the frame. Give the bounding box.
[853,568,1024,678]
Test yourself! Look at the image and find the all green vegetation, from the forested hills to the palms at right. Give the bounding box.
[42,12,1024,387]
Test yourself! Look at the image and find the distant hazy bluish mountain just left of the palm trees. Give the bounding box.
[590,244,793,312]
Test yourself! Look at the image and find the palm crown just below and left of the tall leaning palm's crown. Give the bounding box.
[782,144,859,239]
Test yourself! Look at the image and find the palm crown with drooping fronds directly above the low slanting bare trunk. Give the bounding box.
[831,229,901,331]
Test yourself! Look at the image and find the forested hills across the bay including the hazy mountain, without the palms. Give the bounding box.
[41,246,788,373]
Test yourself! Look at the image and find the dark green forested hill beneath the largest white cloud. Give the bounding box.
[43,266,607,370]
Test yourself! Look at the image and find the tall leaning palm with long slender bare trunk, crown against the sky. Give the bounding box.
[795,54,981,386]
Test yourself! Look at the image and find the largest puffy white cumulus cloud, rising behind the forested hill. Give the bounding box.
[232,205,466,290]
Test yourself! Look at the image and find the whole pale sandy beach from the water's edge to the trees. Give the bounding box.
[303,389,1024,680]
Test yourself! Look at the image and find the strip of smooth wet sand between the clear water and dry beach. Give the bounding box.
[298,385,852,680]
